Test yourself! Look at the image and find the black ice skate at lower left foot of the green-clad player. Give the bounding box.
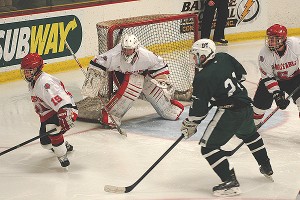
[213,170,241,197]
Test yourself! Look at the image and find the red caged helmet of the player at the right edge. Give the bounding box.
[266,24,287,51]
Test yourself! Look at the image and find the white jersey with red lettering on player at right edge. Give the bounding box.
[258,37,300,93]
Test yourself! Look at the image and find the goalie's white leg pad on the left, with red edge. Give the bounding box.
[102,74,144,125]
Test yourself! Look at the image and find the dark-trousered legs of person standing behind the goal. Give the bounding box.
[201,0,229,45]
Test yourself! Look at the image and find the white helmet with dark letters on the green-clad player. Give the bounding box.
[190,39,216,68]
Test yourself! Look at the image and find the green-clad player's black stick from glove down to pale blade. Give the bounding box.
[104,134,184,194]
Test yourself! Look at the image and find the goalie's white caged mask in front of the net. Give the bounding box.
[121,34,140,64]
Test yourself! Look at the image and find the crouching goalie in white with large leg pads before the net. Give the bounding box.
[82,34,184,127]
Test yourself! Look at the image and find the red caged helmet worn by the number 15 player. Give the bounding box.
[21,53,44,82]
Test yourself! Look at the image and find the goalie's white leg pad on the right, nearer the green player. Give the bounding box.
[143,78,184,120]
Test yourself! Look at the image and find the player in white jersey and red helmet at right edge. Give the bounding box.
[253,24,300,124]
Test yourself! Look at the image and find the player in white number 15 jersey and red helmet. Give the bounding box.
[21,53,78,167]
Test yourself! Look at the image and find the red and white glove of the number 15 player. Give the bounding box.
[57,108,78,131]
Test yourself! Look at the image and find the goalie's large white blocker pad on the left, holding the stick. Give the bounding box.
[81,65,108,97]
